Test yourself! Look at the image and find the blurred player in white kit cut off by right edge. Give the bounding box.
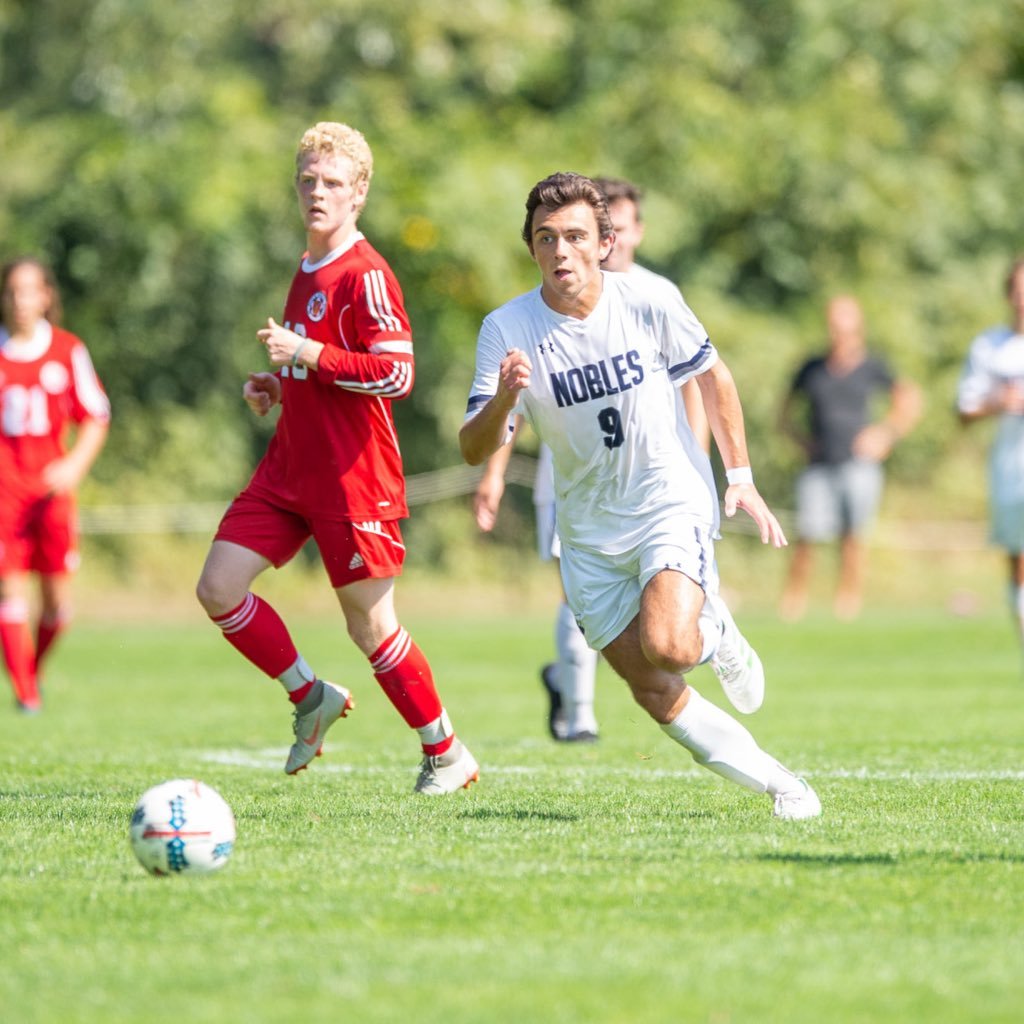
[957,257,1024,644]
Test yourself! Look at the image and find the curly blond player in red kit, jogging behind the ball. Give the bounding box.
[197,122,479,796]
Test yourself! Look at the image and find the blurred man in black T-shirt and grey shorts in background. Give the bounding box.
[779,295,921,622]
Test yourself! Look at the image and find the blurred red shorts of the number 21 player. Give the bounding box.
[0,495,79,577]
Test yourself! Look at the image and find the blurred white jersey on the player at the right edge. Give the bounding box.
[956,327,1024,512]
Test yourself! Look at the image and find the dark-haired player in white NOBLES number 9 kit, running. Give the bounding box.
[460,174,821,818]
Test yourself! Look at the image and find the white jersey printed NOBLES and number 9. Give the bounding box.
[467,272,718,554]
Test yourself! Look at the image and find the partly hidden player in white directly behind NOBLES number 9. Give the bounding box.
[473,178,711,742]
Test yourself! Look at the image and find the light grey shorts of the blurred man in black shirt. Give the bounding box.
[797,459,885,543]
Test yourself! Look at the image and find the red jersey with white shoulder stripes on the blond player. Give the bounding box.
[249,231,414,522]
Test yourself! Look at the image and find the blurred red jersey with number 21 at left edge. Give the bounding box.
[0,321,111,500]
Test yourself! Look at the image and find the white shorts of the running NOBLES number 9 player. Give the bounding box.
[560,514,718,650]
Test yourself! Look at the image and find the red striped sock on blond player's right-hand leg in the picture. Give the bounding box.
[370,626,455,755]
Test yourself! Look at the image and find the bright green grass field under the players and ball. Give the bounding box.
[0,602,1024,1024]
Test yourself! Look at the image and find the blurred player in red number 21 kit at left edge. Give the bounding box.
[0,258,111,713]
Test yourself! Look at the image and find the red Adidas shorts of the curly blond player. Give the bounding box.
[214,490,406,589]
